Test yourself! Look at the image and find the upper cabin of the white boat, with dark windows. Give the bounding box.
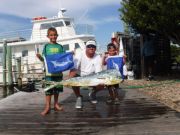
[31,9,76,41]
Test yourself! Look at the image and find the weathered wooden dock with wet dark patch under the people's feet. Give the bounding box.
[0,89,180,135]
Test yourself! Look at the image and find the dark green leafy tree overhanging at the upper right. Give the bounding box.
[119,0,180,43]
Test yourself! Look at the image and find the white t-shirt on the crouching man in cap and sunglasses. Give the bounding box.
[74,52,102,76]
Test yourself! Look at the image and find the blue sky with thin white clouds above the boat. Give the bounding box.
[0,0,123,46]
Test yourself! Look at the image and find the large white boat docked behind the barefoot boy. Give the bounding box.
[0,9,95,83]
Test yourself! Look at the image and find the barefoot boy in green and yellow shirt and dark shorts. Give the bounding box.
[36,27,65,116]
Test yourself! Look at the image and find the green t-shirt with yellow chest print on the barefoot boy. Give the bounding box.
[42,43,65,76]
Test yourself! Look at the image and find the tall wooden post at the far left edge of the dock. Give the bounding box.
[3,40,7,87]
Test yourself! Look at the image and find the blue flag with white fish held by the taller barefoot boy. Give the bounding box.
[45,52,74,73]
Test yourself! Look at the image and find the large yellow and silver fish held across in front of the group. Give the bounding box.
[44,69,122,91]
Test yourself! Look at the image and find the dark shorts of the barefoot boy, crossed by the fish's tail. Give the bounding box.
[45,76,63,96]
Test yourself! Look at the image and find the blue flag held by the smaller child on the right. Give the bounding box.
[107,56,124,79]
